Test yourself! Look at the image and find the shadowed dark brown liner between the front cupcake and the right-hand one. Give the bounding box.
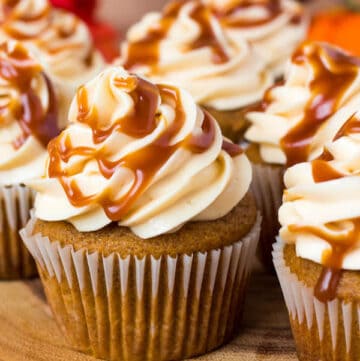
[251,163,284,270]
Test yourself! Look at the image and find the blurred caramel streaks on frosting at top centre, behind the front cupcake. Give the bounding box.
[123,0,229,69]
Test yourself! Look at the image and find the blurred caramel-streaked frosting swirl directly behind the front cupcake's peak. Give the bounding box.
[120,0,273,110]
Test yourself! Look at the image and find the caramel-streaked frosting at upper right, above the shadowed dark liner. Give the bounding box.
[245,42,360,166]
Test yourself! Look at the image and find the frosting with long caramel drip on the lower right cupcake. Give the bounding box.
[279,112,360,301]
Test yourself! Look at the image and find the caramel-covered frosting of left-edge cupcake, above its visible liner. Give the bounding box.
[0,41,59,185]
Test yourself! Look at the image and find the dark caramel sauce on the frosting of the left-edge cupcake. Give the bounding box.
[0,43,60,149]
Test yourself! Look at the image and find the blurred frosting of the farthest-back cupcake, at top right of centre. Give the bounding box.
[204,0,308,77]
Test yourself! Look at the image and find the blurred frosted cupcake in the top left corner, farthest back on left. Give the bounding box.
[0,0,104,126]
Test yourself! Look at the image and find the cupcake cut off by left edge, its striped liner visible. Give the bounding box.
[0,41,60,279]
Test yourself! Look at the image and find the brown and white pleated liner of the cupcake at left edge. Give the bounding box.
[0,185,37,279]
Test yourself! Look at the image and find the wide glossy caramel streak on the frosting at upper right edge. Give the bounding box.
[280,43,360,166]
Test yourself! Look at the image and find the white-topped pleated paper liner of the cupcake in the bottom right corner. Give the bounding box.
[273,240,360,361]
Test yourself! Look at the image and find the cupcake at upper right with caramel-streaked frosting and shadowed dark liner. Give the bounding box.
[245,43,360,268]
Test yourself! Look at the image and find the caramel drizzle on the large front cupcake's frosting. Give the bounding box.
[48,77,241,221]
